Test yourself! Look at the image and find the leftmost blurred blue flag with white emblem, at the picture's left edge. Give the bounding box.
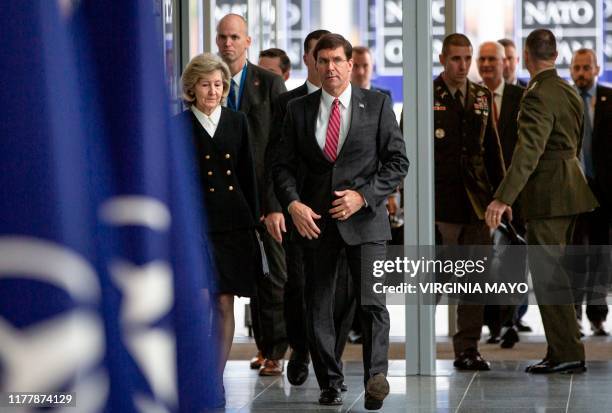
[0,0,109,412]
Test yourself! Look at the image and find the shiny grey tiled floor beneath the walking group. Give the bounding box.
[216,360,612,413]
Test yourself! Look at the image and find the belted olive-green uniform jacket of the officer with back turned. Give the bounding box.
[495,69,597,220]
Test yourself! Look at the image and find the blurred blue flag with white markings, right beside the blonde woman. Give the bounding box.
[70,0,221,412]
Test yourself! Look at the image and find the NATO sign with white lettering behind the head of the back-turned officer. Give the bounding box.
[517,0,604,76]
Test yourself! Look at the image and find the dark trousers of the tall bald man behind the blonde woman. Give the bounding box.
[251,230,288,360]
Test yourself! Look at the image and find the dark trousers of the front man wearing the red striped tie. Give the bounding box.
[304,223,389,390]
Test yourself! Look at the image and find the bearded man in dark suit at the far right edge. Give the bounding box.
[570,49,612,336]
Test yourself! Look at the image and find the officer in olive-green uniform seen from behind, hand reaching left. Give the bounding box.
[485,29,597,373]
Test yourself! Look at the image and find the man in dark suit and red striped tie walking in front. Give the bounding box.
[273,34,408,409]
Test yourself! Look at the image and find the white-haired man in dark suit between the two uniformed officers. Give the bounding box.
[476,42,527,348]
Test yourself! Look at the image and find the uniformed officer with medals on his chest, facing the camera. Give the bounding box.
[433,33,504,370]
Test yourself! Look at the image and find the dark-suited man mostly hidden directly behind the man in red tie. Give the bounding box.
[264,30,344,385]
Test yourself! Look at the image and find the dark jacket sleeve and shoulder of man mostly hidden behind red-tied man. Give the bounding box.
[263,82,308,215]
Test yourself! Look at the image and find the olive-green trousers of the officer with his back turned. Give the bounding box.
[527,216,584,363]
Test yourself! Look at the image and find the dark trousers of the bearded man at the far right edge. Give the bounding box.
[571,208,610,323]
